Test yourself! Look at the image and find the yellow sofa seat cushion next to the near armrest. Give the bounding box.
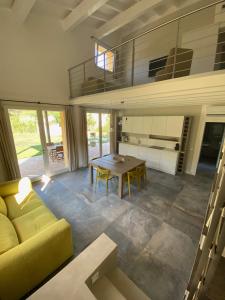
[12,205,57,242]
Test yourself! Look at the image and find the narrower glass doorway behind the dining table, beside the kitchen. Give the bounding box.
[86,112,111,161]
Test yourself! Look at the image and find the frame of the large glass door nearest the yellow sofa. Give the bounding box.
[3,101,69,180]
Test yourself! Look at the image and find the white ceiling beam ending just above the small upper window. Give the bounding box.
[95,0,162,39]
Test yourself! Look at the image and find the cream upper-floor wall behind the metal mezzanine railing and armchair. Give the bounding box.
[120,7,218,84]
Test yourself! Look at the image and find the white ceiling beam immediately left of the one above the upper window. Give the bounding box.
[62,0,108,31]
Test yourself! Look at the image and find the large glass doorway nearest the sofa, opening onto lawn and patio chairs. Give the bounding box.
[8,107,68,179]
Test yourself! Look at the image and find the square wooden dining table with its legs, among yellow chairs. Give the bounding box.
[89,154,145,198]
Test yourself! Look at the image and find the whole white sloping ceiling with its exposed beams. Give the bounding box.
[0,0,213,38]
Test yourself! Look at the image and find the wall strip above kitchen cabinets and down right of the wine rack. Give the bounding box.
[120,106,202,175]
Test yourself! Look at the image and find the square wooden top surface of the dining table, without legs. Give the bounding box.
[90,154,145,176]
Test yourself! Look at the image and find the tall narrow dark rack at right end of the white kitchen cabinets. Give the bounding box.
[177,117,191,174]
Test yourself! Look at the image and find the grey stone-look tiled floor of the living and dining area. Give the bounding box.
[33,169,212,300]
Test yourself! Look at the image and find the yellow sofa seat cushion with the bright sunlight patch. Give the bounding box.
[4,191,43,220]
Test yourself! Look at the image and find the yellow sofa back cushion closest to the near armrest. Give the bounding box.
[0,214,19,254]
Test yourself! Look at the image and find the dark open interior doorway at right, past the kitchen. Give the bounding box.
[197,122,225,176]
